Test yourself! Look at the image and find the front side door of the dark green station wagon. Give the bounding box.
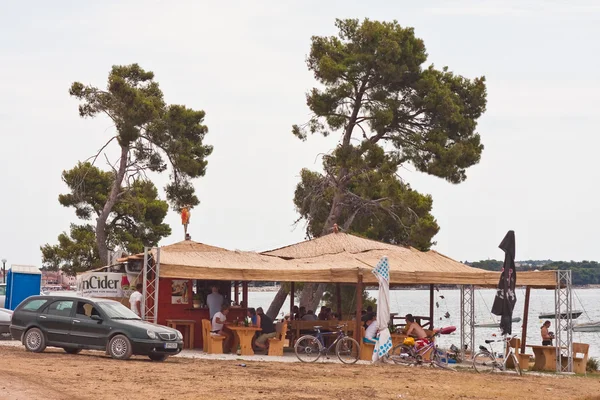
[71,300,111,348]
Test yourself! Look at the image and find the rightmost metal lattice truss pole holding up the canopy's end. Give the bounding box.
[554,271,573,372]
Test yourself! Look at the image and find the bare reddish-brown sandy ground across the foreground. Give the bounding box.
[0,347,600,400]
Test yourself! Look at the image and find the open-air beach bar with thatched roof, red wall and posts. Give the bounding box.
[97,232,572,371]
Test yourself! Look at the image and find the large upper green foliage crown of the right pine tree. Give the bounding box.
[292,19,486,183]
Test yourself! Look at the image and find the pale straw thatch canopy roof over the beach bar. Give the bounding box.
[123,233,556,288]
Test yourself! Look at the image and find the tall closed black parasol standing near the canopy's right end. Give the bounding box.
[492,231,517,335]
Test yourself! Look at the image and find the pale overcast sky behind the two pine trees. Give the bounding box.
[0,0,600,266]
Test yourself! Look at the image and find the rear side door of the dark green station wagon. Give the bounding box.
[38,299,75,344]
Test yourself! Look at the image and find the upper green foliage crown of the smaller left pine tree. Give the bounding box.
[69,64,212,211]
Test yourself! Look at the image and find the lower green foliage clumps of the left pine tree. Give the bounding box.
[41,162,171,274]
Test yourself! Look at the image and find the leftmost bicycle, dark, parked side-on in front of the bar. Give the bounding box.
[294,325,360,364]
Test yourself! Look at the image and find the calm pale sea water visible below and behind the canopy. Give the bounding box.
[248,289,600,358]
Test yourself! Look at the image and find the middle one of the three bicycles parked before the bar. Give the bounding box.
[389,326,456,371]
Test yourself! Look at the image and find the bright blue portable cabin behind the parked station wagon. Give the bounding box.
[4,265,42,310]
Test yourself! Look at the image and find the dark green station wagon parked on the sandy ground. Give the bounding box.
[10,295,183,361]
